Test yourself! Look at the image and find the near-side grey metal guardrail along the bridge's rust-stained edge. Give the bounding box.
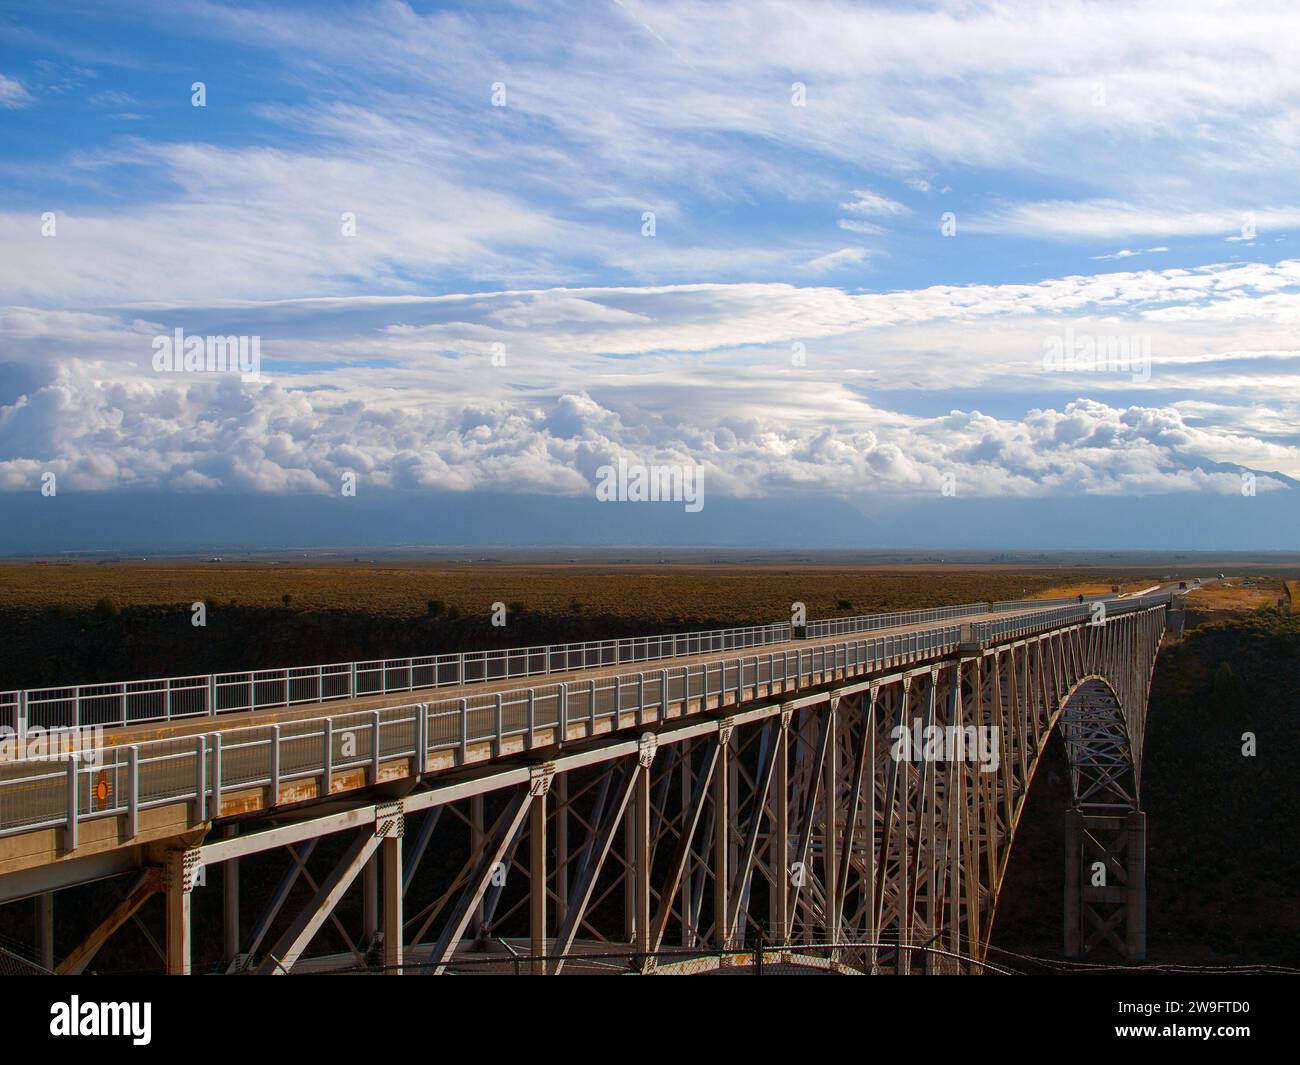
[0,593,1173,849]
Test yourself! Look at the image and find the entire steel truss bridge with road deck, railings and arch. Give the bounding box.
[0,590,1182,974]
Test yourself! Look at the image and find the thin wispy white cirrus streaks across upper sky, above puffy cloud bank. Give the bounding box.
[10,0,1300,302]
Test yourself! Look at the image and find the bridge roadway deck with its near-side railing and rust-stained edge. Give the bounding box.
[0,597,1180,876]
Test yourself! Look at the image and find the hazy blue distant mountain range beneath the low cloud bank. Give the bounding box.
[0,488,1300,555]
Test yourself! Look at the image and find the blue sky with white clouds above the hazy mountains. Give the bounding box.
[0,0,1300,546]
